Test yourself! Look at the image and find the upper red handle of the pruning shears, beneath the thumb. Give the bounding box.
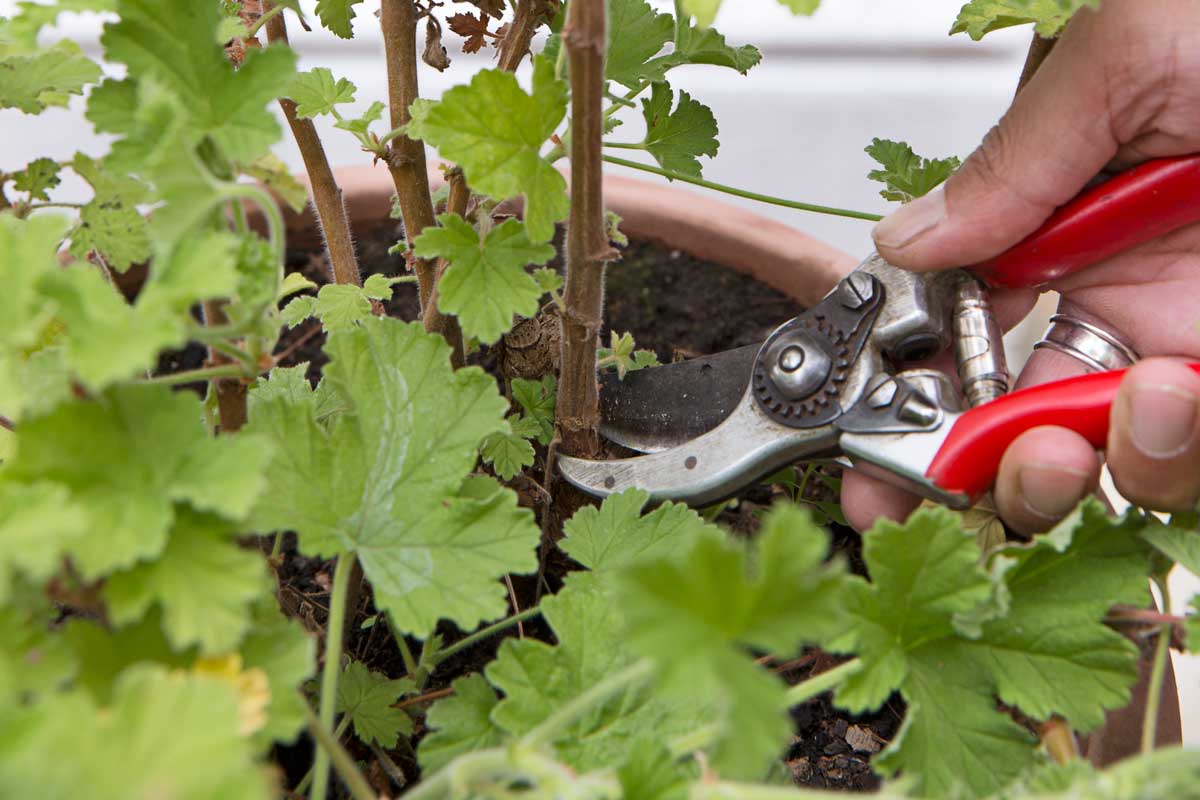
[971,155,1200,288]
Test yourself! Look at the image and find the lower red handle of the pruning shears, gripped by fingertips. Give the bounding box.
[925,363,1200,499]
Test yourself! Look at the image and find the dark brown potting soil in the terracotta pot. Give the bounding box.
[208,219,902,790]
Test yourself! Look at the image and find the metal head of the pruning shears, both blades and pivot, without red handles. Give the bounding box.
[558,255,979,505]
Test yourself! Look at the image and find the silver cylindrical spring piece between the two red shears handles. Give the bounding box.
[953,280,1009,407]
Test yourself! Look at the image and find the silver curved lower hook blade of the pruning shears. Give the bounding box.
[558,392,838,506]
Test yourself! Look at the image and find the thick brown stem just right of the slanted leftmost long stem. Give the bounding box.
[379,0,462,359]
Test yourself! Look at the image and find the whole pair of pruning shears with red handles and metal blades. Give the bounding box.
[558,155,1200,509]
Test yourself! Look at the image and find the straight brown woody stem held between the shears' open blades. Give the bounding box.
[556,0,612,456]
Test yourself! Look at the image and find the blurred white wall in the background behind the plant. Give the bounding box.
[0,0,1200,744]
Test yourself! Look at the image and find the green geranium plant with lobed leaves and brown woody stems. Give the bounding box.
[0,0,1200,800]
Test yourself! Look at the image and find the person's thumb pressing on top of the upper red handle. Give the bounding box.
[874,12,1118,270]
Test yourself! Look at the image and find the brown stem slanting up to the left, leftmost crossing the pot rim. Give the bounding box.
[266,6,362,285]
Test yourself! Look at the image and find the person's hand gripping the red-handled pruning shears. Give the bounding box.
[842,0,1200,533]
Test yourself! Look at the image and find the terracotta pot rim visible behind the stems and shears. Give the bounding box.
[284,164,858,306]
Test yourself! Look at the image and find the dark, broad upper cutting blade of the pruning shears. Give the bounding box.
[600,344,761,452]
